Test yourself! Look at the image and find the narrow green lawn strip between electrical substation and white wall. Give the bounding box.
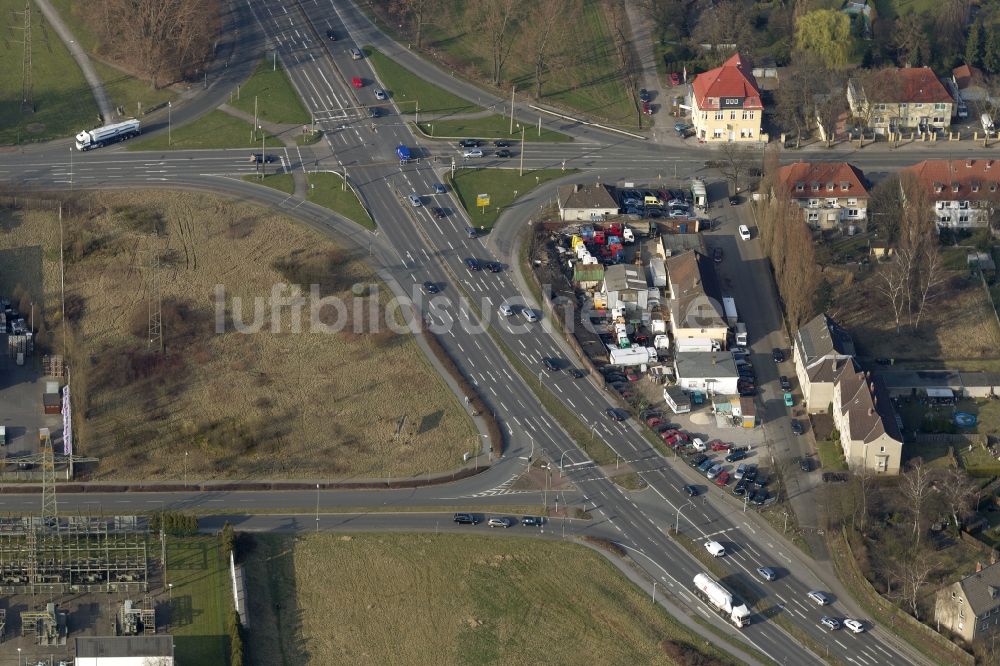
[166,536,232,666]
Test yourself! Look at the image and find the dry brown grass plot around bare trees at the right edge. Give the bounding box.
[824,267,1000,361]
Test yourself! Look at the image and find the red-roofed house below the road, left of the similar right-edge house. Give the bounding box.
[775,162,868,230]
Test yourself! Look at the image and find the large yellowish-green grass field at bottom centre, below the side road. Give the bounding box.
[247,534,735,666]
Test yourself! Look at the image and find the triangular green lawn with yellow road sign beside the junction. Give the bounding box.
[449,169,575,231]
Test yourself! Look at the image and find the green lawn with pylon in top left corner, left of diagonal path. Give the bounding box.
[0,0,101,145]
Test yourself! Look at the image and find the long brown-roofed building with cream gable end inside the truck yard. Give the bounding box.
[664,250,729,346]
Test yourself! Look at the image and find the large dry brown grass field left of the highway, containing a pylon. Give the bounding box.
[0,192,478,481]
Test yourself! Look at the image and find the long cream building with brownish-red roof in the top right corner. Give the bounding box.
[847,67,954,134]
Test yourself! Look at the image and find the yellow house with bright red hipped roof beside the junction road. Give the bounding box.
[690,53,764,141]
